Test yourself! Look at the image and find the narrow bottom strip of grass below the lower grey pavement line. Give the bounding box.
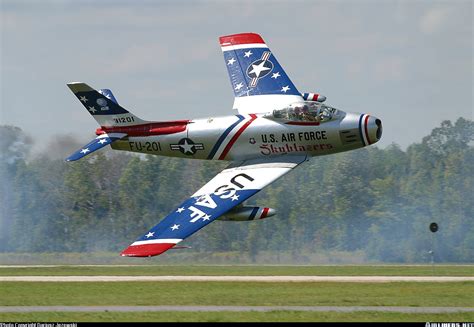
[0,311,474,322]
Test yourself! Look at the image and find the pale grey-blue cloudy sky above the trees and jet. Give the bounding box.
[0,0,474,151]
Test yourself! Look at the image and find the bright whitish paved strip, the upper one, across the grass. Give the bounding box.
[0,276,474,283]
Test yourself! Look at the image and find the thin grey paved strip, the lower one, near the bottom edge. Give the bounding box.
[0,305,474,313]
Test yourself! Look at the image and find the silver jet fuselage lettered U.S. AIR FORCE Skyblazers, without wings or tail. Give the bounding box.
[111,113,381,160]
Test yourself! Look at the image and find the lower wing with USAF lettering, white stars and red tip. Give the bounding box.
[121,156,306,257]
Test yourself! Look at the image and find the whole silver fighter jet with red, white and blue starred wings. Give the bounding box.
[66,33,382,257]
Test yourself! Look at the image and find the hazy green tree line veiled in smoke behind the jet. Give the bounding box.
[0,118,474,262]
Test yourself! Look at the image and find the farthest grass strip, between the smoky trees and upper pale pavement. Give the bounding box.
[0,265,474,276]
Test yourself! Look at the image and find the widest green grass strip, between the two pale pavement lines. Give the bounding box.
[0,282,474,307]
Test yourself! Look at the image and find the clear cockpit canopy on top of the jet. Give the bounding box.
[266,101,344,123]
